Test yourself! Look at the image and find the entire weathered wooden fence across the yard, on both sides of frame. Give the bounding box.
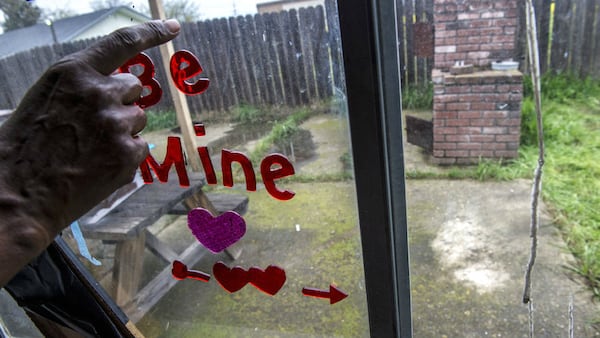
[0,0,600,116]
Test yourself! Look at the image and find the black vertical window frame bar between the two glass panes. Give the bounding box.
[337,0,412,337]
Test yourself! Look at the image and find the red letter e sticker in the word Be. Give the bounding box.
[171,50,210,95]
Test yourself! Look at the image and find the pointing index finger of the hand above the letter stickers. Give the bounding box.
[73,19,181,75]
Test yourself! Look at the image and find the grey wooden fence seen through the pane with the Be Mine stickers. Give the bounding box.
[0,0,345,115]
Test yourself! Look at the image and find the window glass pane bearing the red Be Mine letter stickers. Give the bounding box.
[0,0,369,337]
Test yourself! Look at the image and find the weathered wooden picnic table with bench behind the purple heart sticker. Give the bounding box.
[80,174,248,322]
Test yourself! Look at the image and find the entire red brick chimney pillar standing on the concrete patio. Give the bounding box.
[432,0,523,164]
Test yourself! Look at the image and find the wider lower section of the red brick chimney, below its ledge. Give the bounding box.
[432,70,523,164]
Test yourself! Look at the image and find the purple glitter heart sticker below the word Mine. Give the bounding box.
[188,208,246,253]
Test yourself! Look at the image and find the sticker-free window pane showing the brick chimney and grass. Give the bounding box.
[406,0,600,337]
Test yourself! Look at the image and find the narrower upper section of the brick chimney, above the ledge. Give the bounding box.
[434,0,521,71]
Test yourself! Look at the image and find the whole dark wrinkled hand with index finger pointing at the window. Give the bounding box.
[0,20,180,287]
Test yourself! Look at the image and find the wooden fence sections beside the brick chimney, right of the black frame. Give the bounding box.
[396,0,600,86]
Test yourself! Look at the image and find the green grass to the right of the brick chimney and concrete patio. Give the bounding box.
[503,75,600,298]
